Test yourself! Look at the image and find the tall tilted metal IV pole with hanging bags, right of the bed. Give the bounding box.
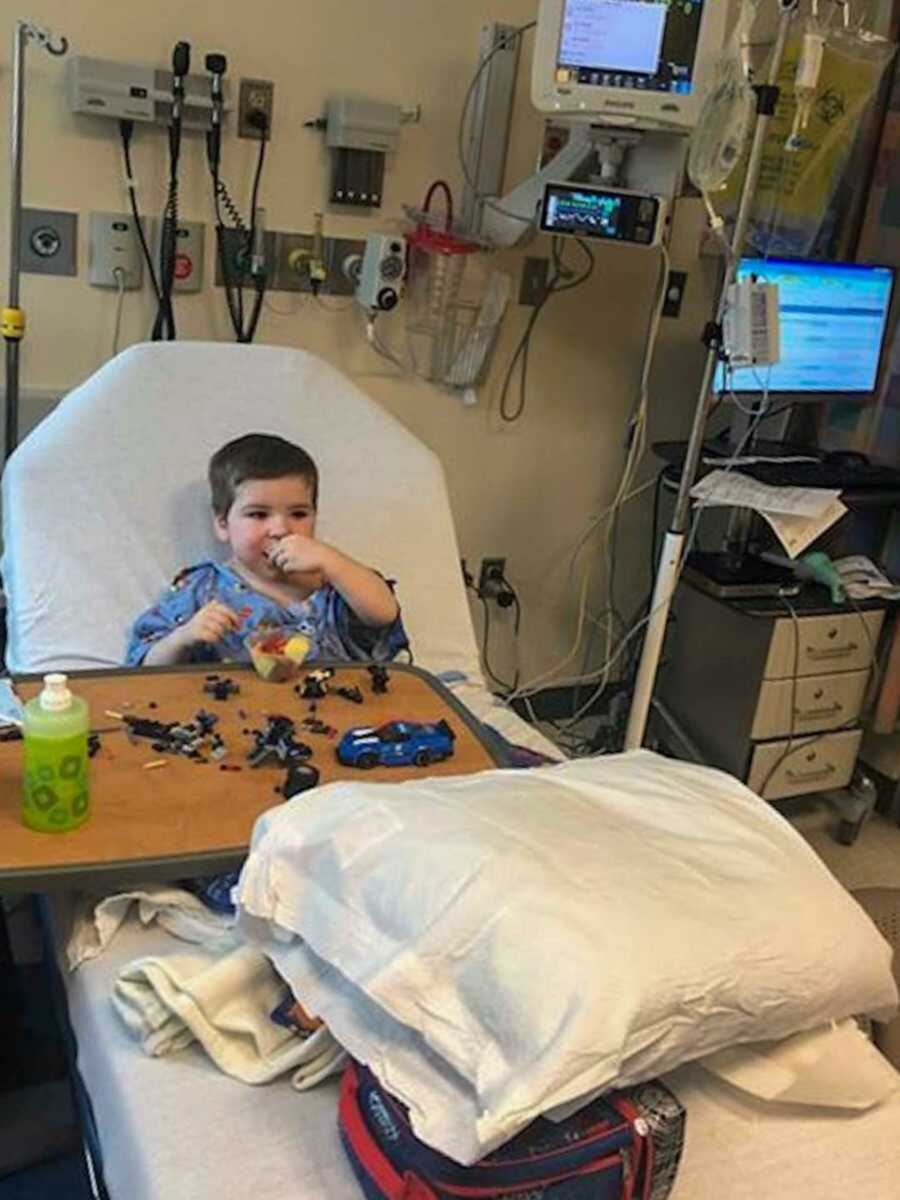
[625,0,799,750]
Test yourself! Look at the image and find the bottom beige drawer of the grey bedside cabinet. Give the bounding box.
[748,730,863,800]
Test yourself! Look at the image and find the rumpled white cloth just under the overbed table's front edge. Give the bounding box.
[66,883,239,971]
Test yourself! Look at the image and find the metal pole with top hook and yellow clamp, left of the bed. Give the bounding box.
[0,20,68,458]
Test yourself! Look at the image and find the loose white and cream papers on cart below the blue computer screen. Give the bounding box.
[691,470,847,558]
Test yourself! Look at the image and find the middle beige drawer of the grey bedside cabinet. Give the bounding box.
[750,671,869,742]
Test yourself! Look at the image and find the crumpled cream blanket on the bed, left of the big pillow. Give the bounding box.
[113,946,346,1091]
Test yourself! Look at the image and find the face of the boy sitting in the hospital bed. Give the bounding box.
[214,475,316,580]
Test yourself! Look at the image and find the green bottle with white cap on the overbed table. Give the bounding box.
[22,674,90,833]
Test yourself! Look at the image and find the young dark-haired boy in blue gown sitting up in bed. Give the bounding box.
[125,433,409,666]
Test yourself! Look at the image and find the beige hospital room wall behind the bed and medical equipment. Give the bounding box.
[0,0,708,677]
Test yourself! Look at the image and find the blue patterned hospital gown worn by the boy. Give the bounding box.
[125,563,409,667]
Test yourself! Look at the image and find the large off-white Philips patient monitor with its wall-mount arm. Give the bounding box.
[481,0,730,246]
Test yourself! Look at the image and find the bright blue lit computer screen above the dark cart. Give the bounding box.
[715,258,894,396]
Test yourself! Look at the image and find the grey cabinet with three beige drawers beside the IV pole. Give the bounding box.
[659,583,884,800]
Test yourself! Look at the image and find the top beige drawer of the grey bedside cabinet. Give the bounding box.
[763,612,884,679]
